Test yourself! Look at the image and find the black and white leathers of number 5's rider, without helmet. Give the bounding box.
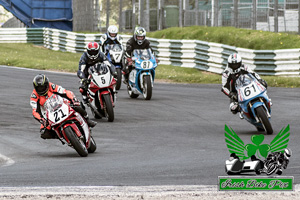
[77,52,117,104]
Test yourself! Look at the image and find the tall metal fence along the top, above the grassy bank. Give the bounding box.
[100,0,299,32]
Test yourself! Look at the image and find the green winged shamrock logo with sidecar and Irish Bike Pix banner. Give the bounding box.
[218,125,294,191]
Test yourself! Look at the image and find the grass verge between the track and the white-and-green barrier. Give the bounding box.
[0,43,300,87]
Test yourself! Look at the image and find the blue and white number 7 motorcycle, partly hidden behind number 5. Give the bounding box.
[105,44,124,90]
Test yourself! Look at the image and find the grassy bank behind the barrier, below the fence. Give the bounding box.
[147,26,300,50]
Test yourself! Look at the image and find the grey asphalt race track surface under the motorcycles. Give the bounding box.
[0,66,300,187]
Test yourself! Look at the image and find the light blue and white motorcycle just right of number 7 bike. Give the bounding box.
[127,49,157,100]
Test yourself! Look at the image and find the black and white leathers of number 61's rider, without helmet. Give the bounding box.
[221,64,267,114]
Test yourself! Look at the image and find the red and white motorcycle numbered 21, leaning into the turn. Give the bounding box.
[44,94,97,157]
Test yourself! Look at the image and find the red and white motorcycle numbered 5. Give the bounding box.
[87,63,117,122]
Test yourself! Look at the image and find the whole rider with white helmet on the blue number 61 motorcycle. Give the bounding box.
[221,53,267,119]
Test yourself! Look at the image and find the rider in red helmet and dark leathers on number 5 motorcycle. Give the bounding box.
[77,42,117,104]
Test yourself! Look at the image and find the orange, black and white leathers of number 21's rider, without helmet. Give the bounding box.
[30,82,96,139]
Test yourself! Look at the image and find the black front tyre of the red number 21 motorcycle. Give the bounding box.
[65,126,88,157]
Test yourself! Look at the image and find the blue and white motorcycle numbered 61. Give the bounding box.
[235,73,273,134]
